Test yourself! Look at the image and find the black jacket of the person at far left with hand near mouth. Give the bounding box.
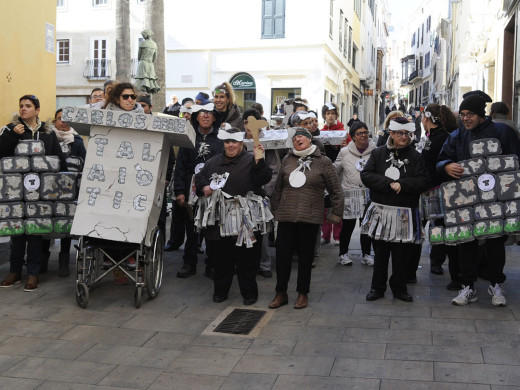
[0,117,67,171]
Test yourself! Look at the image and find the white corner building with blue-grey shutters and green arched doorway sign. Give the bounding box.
[165,0,375,126]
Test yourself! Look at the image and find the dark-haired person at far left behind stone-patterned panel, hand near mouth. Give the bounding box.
[0,95,67,291]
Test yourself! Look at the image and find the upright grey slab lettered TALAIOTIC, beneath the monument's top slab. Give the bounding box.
[71,126,169,243]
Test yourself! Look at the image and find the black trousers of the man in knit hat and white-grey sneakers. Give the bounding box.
[457,236,507,288]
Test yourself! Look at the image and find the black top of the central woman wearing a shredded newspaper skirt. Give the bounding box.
[195,150,273,196]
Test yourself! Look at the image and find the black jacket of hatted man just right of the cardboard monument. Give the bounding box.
[173,121,224,199]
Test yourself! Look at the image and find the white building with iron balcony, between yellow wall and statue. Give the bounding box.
[53,0,147,107]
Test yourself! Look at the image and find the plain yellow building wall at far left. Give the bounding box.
[0,0,56,127]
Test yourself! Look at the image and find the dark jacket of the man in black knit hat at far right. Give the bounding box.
[437,118,520,174]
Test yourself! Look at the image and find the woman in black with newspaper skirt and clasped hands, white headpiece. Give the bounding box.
[361,117,430,302]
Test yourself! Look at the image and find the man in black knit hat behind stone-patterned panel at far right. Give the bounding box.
[437,94,520,306]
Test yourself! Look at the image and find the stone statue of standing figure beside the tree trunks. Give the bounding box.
[135,29,161,94]
